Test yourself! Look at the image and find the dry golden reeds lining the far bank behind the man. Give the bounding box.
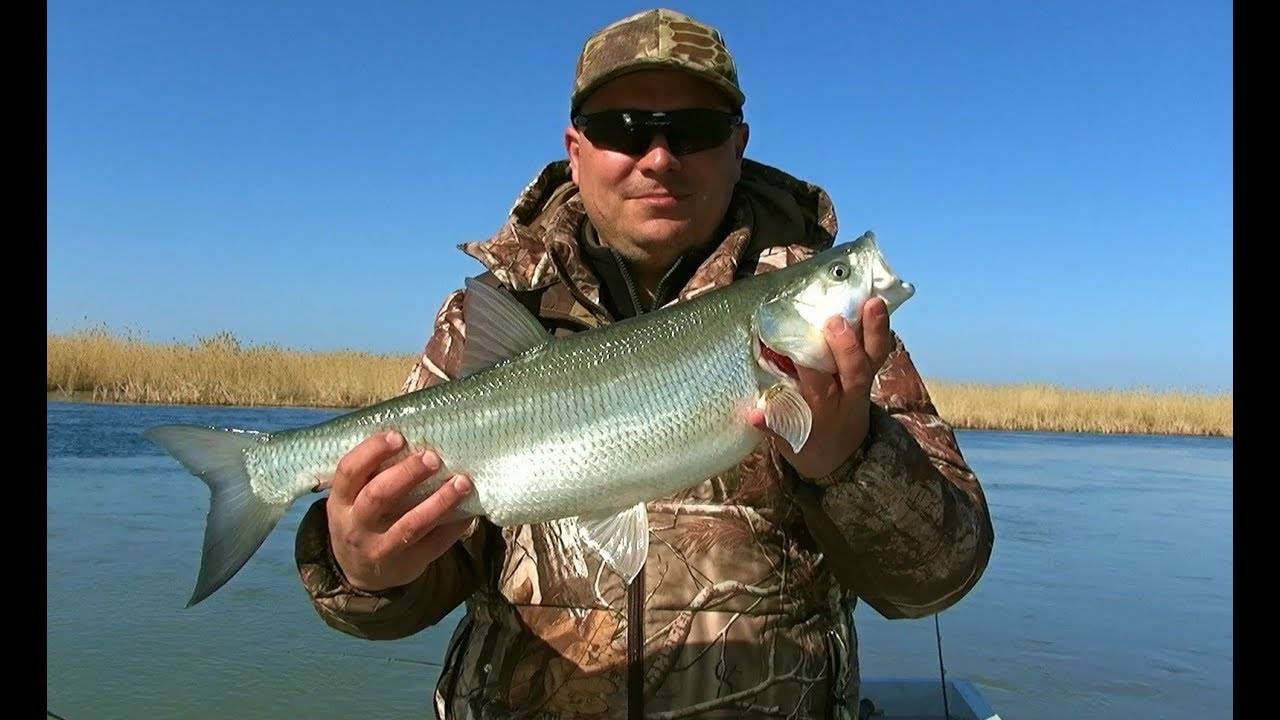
[46,328,1233,437]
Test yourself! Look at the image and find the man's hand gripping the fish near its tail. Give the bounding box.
[326,430,472,592]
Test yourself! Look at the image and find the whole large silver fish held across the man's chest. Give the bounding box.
[146,233,915,607]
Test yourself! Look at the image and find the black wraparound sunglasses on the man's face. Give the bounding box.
[573,108,742,155]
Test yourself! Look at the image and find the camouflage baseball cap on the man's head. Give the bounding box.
[570,8,746,115]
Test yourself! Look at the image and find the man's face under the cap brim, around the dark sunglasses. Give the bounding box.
[564,70,748,270]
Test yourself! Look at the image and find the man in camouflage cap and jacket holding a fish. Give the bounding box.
[297,10,992,719]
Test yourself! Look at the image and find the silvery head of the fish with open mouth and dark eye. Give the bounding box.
[755,232,915,383]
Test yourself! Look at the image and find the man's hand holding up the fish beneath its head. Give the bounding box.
[750,297,893,478]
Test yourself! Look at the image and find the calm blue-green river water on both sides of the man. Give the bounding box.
[46,402,1233,720]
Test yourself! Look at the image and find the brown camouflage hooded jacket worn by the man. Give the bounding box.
[297,160,993,720]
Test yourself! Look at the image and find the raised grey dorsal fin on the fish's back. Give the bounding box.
[458,278,552,378]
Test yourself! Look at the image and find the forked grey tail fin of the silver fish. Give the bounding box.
[143,425,292,607]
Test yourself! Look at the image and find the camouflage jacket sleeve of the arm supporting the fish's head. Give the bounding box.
[777,334,995,619]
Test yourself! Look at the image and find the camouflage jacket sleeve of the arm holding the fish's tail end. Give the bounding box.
[294,291,486,639]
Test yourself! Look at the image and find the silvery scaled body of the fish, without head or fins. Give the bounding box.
[260,288,760,525]
